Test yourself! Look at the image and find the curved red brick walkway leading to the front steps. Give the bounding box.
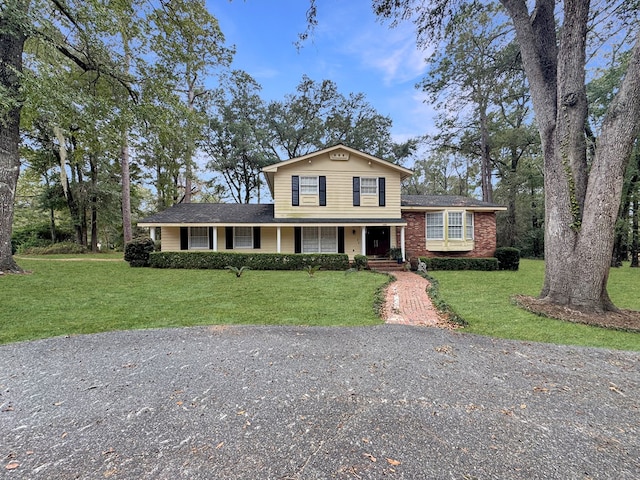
[383,272,446,327]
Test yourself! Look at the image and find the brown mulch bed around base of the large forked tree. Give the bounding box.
[513,295,640,332]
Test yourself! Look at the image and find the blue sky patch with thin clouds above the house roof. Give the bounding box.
[208,0,433,142]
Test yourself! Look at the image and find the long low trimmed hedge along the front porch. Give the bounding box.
[149,252,349,270]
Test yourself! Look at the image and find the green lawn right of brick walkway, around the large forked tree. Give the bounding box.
[431,260,640,350]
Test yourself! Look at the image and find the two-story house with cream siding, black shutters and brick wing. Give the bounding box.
[138,145,505,259]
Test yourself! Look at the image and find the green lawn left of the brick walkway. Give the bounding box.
[0,254,388,343]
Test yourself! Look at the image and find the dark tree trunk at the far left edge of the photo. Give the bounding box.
[0,0,27,273]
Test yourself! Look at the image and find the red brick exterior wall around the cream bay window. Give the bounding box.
[396,211,496,258]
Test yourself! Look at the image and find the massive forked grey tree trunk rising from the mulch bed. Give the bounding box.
[501,0,640,312]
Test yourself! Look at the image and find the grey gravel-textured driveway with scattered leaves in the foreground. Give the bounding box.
[0,325,640,480]
